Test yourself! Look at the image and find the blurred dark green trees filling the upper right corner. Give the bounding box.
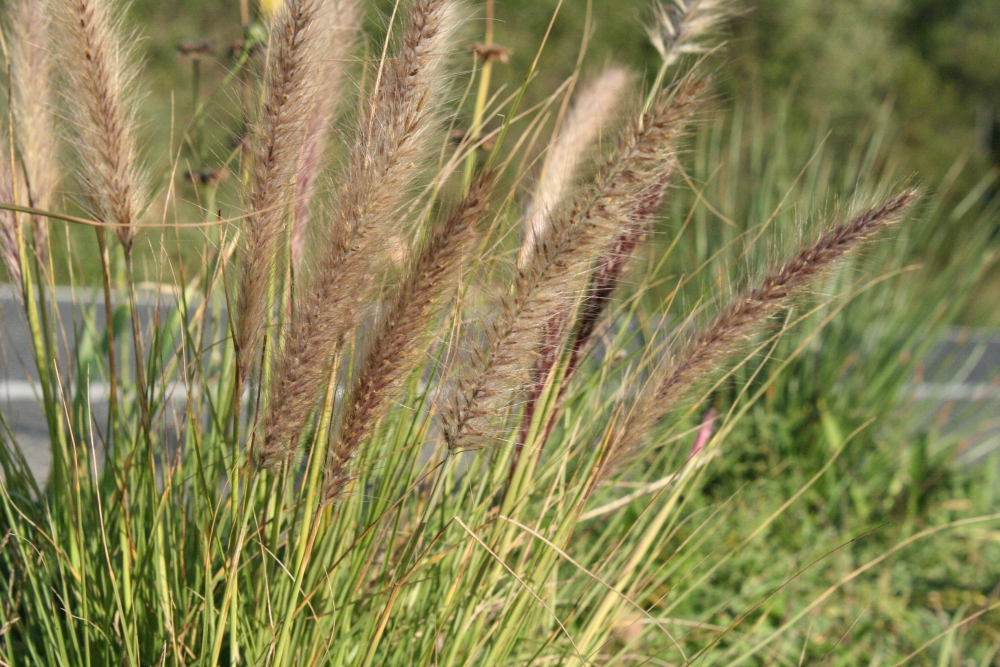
[731,0,1000,179]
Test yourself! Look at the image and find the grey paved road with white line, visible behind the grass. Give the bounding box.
[0,285,1000,479]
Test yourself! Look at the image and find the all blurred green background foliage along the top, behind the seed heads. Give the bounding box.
[132,0,1000,179]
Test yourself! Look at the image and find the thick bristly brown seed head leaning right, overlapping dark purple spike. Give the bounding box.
[443,79,705,449]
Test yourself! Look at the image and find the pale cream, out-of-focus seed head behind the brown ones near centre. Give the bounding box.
[521,67,629,263]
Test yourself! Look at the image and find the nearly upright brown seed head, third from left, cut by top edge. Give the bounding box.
[236,0,340,377]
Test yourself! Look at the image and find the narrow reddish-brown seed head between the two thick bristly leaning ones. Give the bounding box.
[324,173,494,502]
